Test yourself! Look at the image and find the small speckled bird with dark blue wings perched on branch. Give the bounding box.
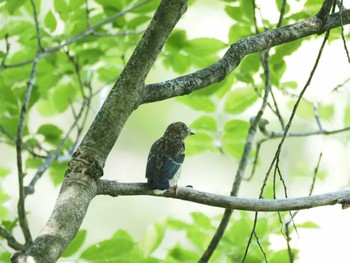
[146,121,195,194]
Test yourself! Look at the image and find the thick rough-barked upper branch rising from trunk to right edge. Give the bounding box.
[143,9,350,103]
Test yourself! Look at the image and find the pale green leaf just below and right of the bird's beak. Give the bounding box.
[186,133,214,156]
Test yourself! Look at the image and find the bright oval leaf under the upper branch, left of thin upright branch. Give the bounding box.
[224,87,259,114]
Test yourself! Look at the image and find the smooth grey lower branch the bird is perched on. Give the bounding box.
[97,180,350,212]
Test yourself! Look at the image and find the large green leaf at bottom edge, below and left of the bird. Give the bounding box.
[80,230,134,263]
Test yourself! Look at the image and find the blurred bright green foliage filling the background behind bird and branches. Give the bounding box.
[0,0,350,262]
